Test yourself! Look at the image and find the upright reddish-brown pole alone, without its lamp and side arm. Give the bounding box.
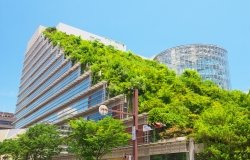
[133,89,138,160]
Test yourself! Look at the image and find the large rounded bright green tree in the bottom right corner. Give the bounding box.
[194,103,250,160]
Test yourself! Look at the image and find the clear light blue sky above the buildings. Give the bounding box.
[0,0,250,112]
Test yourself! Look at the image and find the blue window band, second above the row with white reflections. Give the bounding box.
[16,69,80,118]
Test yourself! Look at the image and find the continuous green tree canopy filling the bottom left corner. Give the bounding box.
[0,124,61,160]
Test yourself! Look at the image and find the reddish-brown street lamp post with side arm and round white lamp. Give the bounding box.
[99,89,138,160]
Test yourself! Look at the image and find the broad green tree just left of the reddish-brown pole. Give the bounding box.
[68,117,130,160]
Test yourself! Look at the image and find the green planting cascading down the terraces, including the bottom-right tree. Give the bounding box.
[44,28,250,159]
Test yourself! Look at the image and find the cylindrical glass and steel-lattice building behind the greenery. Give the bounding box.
[154,44,230,89]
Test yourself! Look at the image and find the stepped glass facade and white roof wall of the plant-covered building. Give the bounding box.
[14,23,126,128]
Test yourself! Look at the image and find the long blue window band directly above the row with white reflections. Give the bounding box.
[16,78,90,128]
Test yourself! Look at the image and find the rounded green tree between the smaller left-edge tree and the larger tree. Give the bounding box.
[19,124,62,160]
